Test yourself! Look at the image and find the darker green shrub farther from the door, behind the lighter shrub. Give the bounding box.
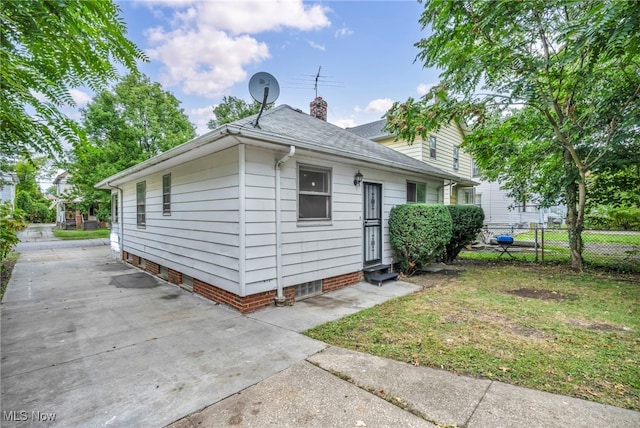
[444,205,484,263]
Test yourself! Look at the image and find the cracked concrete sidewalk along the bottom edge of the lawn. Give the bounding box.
[170,347,640,428]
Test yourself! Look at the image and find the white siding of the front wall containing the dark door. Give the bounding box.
[246,147,442,294]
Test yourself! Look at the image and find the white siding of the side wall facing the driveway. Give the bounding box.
[121,147,240,294]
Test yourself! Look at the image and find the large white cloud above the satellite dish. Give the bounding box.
[145,0,331,97]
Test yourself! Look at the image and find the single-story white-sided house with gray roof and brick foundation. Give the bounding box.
[96,105,459,313]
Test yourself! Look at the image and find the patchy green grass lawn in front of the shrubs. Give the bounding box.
[306,261,640,410]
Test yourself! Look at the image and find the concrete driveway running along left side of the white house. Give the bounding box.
[1,236,326,427]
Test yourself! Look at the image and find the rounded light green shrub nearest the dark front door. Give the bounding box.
[389,204,451,275]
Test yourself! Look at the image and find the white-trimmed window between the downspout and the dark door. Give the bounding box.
[298,164,331,220]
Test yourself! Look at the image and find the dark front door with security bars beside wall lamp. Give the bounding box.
[363,183,382,266]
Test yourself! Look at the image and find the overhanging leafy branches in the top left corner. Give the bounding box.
[0,0,146,162]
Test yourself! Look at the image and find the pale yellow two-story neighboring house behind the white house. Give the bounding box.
[347,119,478,205]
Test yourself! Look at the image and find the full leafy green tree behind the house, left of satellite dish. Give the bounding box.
[67,74,195,217]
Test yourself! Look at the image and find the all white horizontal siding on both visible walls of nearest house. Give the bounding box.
[120,146,458,295]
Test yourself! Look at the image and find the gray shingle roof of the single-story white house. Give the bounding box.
[228,104,460,181]
